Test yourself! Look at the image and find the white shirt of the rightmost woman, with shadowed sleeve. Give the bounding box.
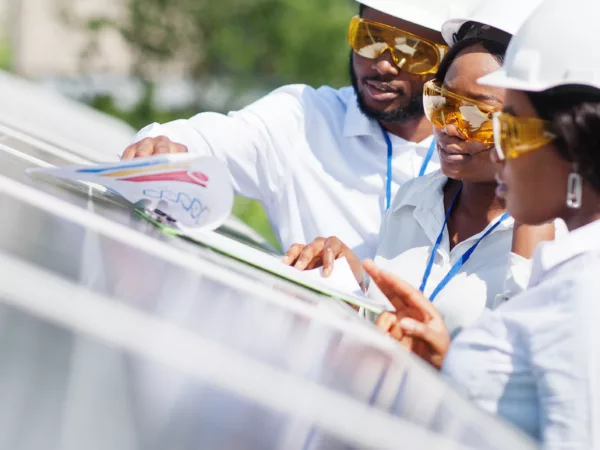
[443,221,600,449]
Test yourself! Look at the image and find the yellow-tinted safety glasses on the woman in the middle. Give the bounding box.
[423,80,499,145]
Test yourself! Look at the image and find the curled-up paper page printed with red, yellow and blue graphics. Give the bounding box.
[27,154,233,230]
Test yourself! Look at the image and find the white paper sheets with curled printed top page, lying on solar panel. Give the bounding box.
[28,154,388,313]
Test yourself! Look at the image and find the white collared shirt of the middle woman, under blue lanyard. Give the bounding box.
[368,171,531,336]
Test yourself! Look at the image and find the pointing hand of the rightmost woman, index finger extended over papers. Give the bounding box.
[364,261,450,369]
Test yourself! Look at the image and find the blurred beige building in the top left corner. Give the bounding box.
[0,0,139,108]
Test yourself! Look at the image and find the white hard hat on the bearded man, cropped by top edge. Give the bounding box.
[358,0,481,31]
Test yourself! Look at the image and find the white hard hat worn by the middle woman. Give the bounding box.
[442,0,544,45]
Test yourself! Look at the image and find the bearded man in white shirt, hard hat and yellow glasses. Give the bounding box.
[123,0,476,258]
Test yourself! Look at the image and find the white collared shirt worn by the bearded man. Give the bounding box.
[129,85,439,258]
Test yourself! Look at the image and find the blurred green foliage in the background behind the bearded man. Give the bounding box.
[76,0,357,248]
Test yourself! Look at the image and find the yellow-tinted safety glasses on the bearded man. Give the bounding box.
[348,16,448,75]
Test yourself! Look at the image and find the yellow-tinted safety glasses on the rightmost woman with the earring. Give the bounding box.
[493,111,556,161]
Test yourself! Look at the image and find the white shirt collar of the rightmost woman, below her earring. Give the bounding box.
[531,220,600,284]
